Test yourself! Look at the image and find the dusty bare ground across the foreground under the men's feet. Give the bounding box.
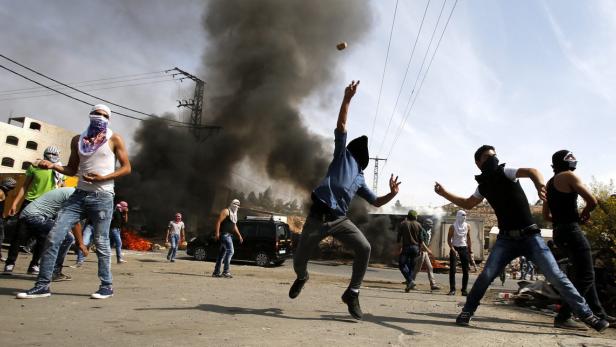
[0,252,616,347]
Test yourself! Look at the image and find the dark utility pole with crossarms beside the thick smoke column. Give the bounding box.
[165,67,222,141]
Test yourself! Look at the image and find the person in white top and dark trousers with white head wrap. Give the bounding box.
[447,210,472,296]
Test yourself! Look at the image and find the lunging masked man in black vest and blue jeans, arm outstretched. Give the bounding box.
[434,145,609,331]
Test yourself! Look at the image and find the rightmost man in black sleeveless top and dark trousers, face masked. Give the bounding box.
[543,150,616,330]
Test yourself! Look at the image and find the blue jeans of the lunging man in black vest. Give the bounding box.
[462,234,592,318]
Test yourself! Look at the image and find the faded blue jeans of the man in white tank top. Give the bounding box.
[36,189,113,287]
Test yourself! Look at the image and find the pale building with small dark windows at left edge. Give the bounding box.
[0,117,76,174]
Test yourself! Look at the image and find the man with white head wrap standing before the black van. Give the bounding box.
[212,199,244,278]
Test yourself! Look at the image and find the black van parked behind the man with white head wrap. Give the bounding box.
[186,217,292,266]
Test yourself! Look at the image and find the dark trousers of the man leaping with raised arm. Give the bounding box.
[293,205,371,290]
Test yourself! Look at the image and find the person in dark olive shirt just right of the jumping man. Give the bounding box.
[398,210,432,293]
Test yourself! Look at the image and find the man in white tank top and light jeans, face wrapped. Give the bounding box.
[19,105,131,299]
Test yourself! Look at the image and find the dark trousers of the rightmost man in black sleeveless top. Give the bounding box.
[554,223,605,321]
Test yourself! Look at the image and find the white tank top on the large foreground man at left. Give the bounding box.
[77,129,116,193]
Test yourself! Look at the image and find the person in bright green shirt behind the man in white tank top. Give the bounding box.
[4,146,60,274]
